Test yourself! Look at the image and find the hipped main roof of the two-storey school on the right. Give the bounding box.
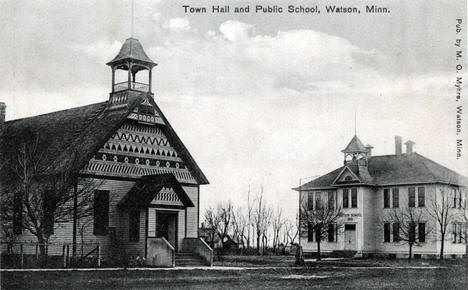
[295,153,468,190]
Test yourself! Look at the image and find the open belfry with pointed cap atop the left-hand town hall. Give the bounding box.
[107,37,157,106]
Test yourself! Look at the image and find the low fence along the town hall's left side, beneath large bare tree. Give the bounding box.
[0,242,101,269]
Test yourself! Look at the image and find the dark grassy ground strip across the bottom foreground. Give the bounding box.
[1,262,467,290]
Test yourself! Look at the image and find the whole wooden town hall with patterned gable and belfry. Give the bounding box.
[0,38,212,266]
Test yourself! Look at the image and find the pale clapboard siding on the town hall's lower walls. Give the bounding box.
[5,179,199,258]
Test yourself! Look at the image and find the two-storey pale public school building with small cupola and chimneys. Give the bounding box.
[295,136,468,257]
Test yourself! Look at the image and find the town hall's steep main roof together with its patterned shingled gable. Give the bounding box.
[0,92,208,184]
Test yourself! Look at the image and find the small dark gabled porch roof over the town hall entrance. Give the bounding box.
[118,173,195,208]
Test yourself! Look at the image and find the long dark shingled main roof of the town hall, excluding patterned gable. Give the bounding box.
[0,91,208,184]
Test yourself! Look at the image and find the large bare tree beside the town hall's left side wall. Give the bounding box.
[1,134,98,253]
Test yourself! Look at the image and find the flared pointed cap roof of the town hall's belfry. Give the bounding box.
[107,38,156,71]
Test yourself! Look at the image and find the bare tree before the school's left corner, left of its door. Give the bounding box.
[299,193,343,260]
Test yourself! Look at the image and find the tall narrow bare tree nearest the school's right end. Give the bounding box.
[426,186,456,259]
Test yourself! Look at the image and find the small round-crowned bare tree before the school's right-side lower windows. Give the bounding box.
[381,207,432,260]
